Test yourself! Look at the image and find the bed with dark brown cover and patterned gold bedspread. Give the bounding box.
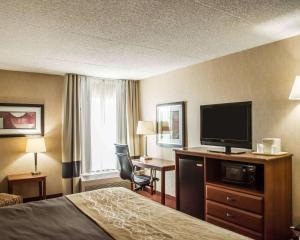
[0,188,248,240]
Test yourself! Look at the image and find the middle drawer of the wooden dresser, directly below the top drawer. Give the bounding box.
[206,200,263,232]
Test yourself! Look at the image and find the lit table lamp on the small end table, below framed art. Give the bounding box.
[26,138,46,175]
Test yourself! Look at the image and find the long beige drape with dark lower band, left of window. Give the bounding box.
[62,74,85,194]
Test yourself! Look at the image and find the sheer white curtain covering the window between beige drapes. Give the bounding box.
[81,77,126,173]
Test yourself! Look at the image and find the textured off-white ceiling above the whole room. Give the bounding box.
[0,0,300,79]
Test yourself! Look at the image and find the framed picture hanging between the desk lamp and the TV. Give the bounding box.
[156,102,186,148]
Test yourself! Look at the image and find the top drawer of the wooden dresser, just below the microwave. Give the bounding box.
[206,185,264,214]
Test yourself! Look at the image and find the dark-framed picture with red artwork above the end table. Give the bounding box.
[0,103,44,137]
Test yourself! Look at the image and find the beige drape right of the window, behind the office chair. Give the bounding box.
[126,80,140,156]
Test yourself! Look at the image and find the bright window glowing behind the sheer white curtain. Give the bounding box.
[91,80,117,171]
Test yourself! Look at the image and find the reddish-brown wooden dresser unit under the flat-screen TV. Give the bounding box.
[175,148,292,240]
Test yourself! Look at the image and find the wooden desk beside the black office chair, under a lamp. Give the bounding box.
[132,158,175,204]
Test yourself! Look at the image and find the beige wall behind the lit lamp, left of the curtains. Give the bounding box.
[0,70,63,197]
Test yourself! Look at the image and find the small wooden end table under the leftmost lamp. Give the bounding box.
[7,173,47,200]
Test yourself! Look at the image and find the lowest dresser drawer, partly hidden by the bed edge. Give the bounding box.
[206,215,263,240]
